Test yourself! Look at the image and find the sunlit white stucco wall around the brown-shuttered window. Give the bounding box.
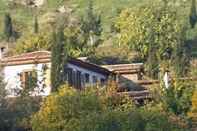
[3,63,51,96]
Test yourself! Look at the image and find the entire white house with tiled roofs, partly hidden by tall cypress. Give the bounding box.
[0,51,145,96]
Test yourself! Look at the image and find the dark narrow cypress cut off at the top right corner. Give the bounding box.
[189,0,197,28]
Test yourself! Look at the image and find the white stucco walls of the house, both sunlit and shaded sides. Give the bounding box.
[3,63,107,96]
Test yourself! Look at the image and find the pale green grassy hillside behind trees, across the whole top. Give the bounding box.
[0,0,197,57]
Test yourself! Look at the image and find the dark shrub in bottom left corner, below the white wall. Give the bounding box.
[0,96,41,131]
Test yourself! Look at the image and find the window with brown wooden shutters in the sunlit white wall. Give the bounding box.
[20,71,37,88]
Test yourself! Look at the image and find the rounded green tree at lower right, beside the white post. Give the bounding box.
[163,80,196,117]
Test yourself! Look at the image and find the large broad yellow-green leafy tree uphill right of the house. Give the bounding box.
[115,2,188,78]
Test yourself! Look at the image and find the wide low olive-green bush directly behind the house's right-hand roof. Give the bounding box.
[88,45,141,65]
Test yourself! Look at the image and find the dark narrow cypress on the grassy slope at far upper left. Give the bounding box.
[4,13,13,41]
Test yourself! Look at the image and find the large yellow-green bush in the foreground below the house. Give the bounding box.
[32,83,132,131]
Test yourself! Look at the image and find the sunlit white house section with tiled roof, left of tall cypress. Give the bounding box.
[0,51,51,96]
